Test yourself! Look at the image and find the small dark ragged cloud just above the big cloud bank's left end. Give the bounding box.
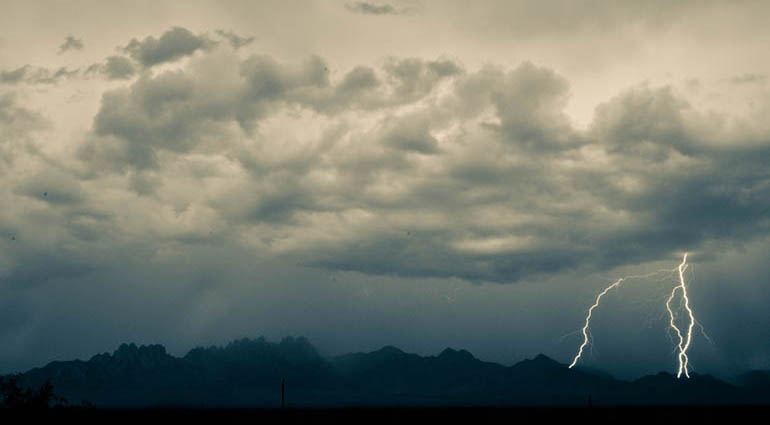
[123,27,216,67]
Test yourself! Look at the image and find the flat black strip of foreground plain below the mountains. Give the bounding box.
[0,406,770,425]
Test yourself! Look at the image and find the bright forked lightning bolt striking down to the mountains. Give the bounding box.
[569,253,705,378]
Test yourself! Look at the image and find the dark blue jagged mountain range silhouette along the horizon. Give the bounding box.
[6,337,770,407]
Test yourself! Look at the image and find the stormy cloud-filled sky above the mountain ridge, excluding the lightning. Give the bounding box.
[0,0,770,379]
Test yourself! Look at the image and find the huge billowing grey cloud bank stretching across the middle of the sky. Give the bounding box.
[58,52,770,282]
